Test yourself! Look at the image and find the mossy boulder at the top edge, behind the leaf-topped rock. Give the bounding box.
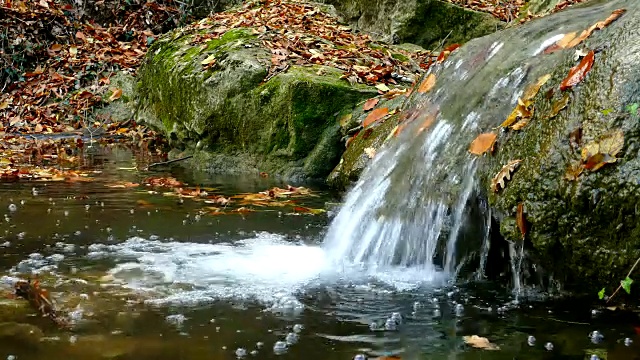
[323,0,505,49]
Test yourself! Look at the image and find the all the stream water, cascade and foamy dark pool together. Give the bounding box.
[0,1,640,360]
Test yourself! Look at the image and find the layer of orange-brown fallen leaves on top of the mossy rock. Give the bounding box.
[187,0,432,84]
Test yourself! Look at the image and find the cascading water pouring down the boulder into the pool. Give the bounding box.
[324,3,619,288]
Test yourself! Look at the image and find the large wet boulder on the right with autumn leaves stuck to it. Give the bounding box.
[332,1,640,293]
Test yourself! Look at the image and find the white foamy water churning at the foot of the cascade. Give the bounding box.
[89,233,444,312]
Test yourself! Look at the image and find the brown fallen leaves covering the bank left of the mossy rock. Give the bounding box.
[0,0,176,179]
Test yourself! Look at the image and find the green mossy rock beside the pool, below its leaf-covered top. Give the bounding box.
[136,28,377,178]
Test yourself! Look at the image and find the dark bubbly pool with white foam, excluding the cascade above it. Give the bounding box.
[0,149,640,360]
